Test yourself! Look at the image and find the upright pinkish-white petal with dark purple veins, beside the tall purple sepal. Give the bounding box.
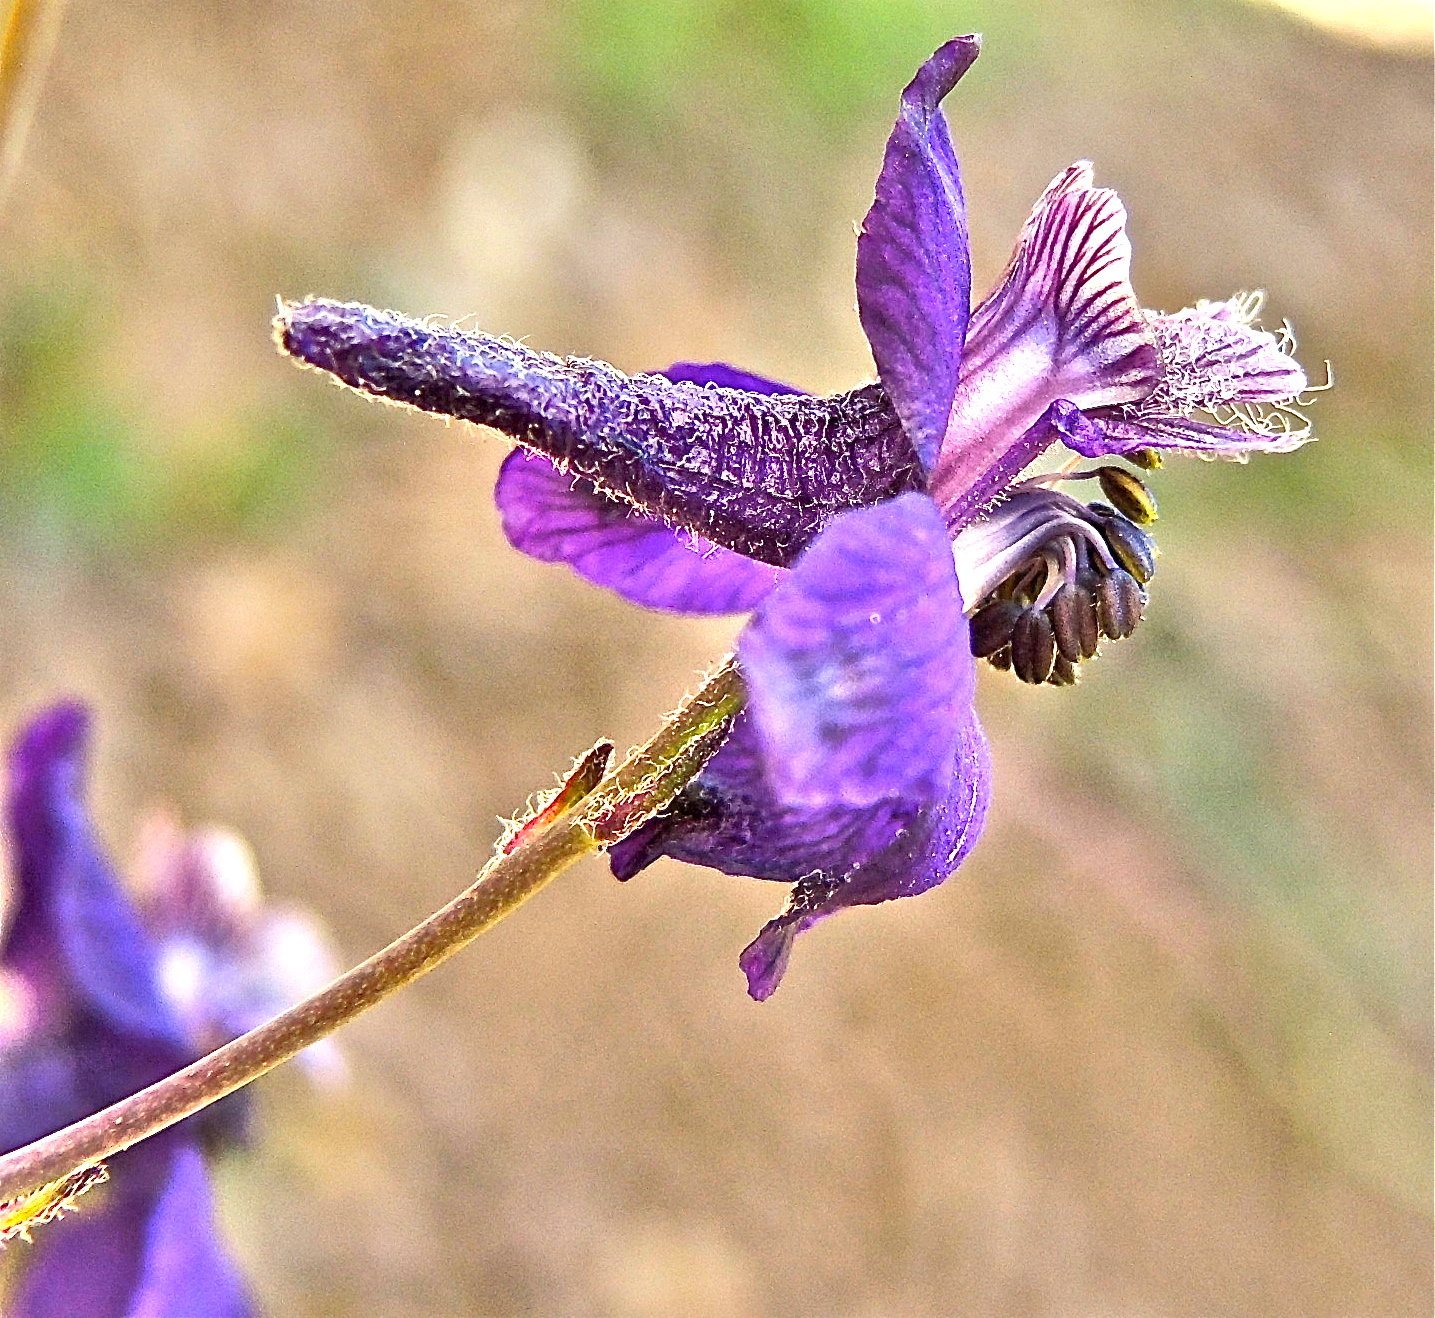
[931,162,1161,528]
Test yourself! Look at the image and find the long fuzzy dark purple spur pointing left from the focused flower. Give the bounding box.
[278,302,924,567]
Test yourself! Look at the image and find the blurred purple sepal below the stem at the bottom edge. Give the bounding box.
[7,1131,254,1318]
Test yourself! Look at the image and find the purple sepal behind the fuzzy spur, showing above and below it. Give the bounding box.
[494,362,802,613]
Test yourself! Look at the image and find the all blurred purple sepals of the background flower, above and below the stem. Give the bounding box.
[0,704,254,1318]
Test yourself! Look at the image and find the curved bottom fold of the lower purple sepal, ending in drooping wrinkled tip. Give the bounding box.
[738,708,992,1002]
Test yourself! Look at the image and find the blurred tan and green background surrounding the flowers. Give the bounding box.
[0,0,1431,1318]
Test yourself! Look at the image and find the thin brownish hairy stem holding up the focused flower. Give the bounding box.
[0,659,743,1202]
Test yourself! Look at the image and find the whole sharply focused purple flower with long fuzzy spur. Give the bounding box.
[277,37,1309,999]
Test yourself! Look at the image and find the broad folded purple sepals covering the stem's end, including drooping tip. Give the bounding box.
[610,495,990,999]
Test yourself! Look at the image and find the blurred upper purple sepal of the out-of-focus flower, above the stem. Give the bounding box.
[0,702,184,1047]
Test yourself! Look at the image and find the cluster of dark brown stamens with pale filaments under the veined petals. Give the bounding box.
[951,457,1157,686]
